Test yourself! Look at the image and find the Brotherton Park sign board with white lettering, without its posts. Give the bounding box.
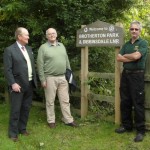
[76,21,124,47]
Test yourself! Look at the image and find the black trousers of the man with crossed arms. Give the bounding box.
[120,71,145,133]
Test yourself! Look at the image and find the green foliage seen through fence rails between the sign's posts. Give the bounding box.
[87,77,115,121]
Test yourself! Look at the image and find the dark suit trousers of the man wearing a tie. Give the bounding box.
[8,82,33,137]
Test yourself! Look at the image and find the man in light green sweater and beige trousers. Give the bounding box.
[37,28,77,128]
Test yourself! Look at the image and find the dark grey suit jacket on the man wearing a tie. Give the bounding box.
[3,43,37,90]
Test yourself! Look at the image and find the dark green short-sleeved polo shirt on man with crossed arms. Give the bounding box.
[120,38,148,70]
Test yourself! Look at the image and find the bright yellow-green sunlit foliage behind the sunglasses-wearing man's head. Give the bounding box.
[119,0,150,42]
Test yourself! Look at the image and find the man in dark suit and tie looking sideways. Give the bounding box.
[3,27,37,142]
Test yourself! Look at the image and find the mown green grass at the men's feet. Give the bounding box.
[0,104,150,150]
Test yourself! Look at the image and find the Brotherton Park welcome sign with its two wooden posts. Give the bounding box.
[76,21,124,123]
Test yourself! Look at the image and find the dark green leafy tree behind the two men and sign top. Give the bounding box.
[0,0,134,56]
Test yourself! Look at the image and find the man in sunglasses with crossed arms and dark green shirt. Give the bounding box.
[115,21,148,142]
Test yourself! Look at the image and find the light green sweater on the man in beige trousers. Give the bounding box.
[37,42,70,82]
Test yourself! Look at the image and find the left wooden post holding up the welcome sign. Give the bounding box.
[81,46,88,118]
